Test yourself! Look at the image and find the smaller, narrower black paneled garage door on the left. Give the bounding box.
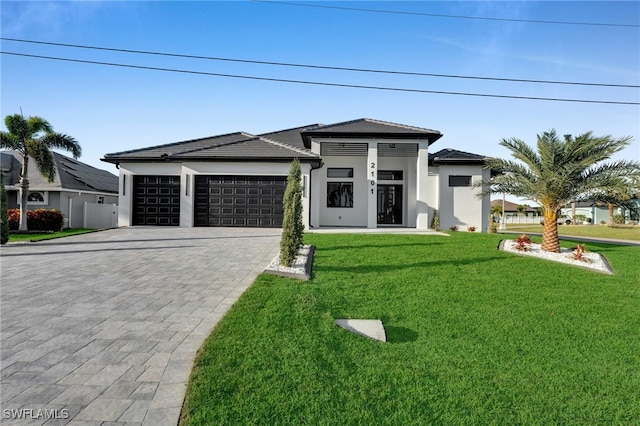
[133,175,180,226]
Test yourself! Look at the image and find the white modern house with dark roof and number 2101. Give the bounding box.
[102,119,489,230]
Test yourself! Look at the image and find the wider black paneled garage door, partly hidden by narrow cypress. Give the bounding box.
[194,175,287,228]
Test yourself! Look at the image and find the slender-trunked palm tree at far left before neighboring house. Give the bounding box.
[0,114,82,231]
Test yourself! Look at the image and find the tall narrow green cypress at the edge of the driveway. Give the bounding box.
[280,159,304,266]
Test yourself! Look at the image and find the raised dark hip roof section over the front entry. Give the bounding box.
[302,118,442,148]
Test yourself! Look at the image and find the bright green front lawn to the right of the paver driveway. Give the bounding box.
[181,232,640,425]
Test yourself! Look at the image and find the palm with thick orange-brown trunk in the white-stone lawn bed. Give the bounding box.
[478,130,640,253]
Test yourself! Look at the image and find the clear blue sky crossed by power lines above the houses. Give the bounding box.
[0,0,640,205]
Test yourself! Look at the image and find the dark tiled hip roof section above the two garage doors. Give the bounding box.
[102,132,319,164]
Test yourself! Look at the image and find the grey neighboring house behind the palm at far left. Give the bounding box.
[0,151,118,228]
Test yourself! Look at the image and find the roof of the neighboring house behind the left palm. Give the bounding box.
[0,151,118,194]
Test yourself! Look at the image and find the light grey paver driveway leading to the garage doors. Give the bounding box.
[0,227,281,426]
